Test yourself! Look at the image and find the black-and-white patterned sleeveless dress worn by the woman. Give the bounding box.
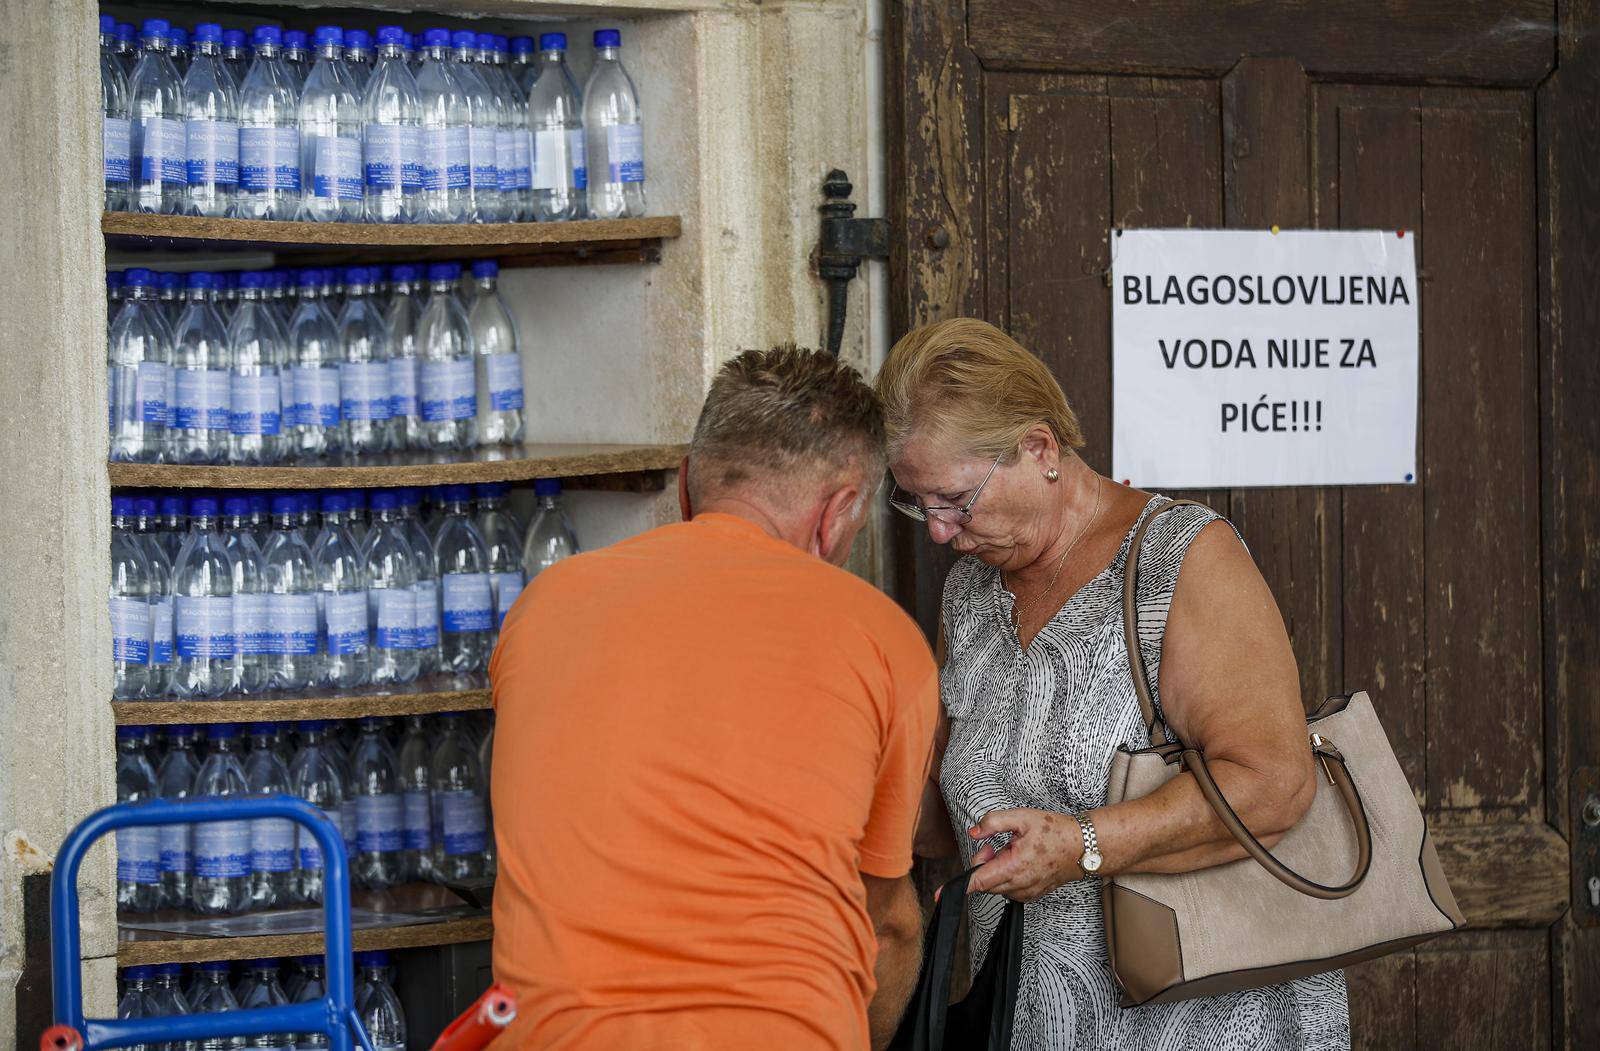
[939,496,1350,1051]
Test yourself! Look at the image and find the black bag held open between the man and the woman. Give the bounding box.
[890,869,1022,1051]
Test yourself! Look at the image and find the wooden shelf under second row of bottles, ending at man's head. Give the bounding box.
[106,443,686,493]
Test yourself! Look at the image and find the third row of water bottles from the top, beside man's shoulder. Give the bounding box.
[110,478,578,701]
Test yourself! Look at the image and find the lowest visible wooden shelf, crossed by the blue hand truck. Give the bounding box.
[117,883,494,968]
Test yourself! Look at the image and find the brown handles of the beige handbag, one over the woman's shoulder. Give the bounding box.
[1122,501,1373,901]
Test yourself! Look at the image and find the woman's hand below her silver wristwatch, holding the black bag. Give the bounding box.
[966,809,1083,902]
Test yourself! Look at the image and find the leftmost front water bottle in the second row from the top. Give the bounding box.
[106,267,172,464]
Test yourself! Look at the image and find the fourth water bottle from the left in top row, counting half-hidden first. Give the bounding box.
[235,26,301,219]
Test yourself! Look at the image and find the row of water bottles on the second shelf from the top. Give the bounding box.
[106,259,525,464]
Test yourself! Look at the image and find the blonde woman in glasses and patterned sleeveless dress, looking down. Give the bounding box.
[877,318,1349,1051]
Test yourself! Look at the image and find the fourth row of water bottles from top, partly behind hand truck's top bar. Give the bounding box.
[115,712,494,917]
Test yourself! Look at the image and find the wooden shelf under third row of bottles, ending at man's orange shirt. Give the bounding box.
[110,689,491,726]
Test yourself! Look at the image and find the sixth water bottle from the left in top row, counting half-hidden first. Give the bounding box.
[362,26,424,222]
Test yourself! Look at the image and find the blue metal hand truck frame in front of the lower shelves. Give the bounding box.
[40,795,373,1051]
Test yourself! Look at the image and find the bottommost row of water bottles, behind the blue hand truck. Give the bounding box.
[117,952,406,1051]
